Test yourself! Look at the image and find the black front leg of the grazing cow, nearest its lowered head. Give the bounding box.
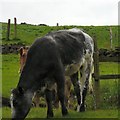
[45,89,53,118]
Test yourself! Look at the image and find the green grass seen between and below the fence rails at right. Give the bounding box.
[99,62,120,109]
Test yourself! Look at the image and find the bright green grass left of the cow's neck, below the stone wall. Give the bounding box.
[2,54,19,97]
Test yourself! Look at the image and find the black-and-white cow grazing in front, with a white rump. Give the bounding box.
[10,29,93,118]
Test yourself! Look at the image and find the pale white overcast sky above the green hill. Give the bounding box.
[0,0,119,26]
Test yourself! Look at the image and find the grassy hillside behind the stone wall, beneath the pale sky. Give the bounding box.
[0,23,118,48]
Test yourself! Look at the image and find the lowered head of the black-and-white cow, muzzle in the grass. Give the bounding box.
[10,87,32,119]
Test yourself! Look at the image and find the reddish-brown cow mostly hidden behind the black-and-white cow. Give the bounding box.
[20,46,71,108]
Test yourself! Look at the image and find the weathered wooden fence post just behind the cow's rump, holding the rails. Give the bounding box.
[93,37,100,109]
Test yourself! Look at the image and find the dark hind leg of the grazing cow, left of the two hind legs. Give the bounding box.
[70,72,81,112]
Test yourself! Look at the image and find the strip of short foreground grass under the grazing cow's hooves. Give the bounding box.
[2,107,118,118]
